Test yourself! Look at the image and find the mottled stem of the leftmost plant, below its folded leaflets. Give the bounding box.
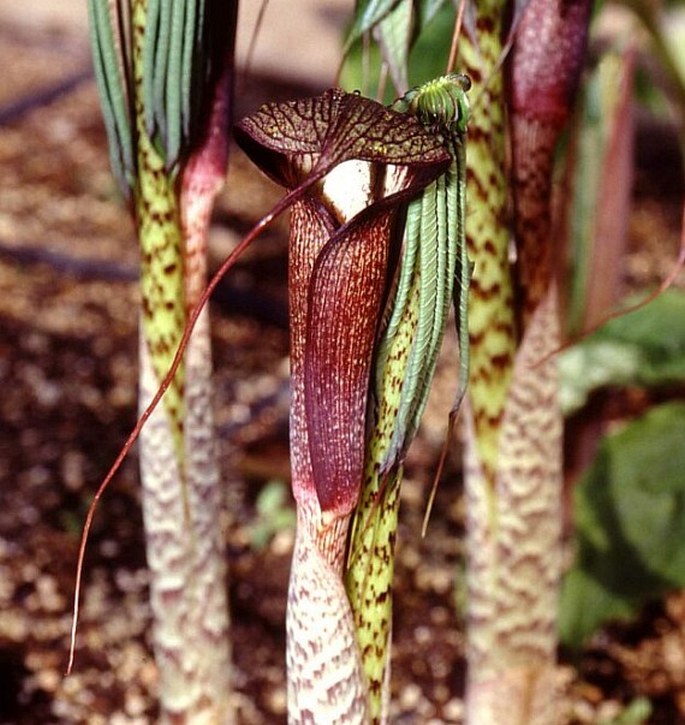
[132,2,233,725]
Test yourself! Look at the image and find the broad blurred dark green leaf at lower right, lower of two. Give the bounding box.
[559,403,685,647]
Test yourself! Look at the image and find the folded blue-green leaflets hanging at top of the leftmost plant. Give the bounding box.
[88,0,208,189]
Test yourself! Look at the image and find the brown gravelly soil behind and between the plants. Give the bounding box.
[0,14,685,724]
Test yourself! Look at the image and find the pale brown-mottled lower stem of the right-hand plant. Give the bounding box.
[465,285,562,725]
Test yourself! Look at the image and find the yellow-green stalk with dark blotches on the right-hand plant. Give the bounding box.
[460,0,516,495]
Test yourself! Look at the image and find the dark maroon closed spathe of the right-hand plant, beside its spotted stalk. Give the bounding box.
[509,0,592,326]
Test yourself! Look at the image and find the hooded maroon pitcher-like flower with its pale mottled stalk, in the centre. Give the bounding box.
[237,90,458,723]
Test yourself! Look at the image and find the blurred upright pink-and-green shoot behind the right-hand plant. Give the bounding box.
[562,49,634,336]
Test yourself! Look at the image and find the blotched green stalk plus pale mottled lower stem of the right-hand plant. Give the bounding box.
[460,2,561,725]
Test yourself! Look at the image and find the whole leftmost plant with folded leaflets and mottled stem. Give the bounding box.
[81,0,237,723]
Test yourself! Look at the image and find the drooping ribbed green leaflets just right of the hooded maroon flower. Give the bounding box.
[377,73,471,471]
